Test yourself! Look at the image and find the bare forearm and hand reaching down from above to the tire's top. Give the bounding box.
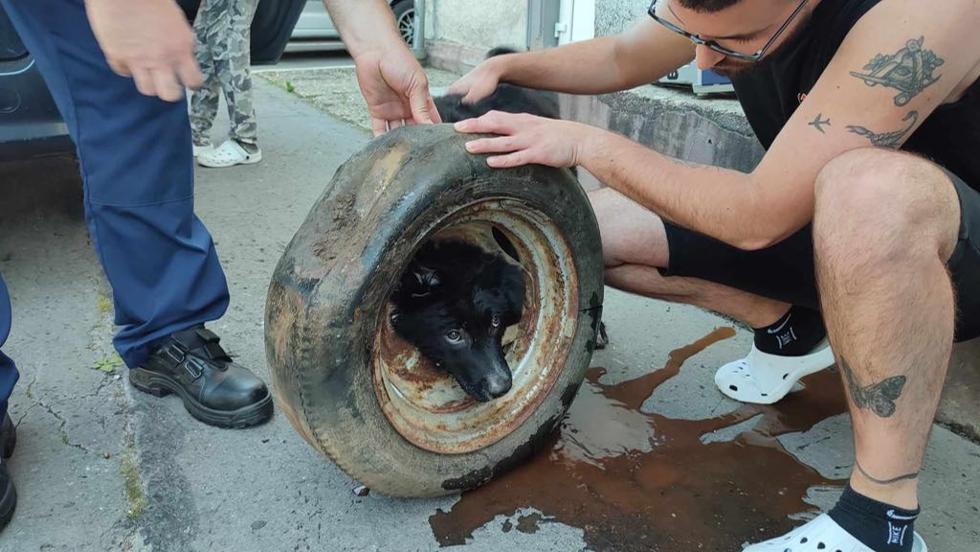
[323,0,441,136]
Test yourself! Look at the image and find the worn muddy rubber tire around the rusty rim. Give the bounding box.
[265,125,603,496]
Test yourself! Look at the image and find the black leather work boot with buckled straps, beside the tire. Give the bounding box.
[129,326,272,428]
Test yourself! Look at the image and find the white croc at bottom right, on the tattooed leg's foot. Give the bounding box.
[742,514,929,552]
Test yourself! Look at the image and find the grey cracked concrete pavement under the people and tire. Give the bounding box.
[0,74,980,552]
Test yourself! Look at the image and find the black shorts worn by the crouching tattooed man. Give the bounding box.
[661,172,980,341]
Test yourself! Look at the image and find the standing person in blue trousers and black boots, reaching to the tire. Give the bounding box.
[0,0,439,530]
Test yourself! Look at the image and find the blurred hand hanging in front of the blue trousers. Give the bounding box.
[85,0,203,102]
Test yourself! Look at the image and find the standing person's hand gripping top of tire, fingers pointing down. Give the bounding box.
[354,38,442,136]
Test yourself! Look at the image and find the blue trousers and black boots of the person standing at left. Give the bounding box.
[0,0,273,529]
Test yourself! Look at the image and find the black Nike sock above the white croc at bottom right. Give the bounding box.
[828,484,919,552]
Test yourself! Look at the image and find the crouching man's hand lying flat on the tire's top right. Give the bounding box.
[455,111,601,169]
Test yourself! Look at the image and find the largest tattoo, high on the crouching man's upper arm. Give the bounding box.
[851,36,946,106]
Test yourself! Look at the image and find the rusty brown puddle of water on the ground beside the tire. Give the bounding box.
[429,328,847,551]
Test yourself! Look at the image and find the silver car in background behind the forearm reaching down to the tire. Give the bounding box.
[286,0,415,52]
